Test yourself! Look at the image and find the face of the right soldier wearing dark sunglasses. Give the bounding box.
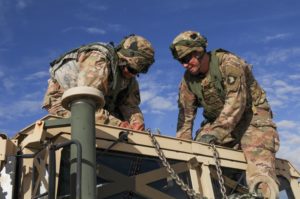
[180,52,202,75]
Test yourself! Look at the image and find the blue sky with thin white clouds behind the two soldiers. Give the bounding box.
[0,0,300,169]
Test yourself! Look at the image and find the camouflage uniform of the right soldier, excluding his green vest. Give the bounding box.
[176,52,279,194]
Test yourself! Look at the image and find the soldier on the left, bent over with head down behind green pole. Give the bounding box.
[43,35,154,130]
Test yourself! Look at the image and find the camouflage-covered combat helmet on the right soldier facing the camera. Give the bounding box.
[170,31,207,60]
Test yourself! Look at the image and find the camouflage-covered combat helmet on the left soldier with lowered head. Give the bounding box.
[116,34,154,73]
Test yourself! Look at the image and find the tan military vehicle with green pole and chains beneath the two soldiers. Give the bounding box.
[0,88,300,199]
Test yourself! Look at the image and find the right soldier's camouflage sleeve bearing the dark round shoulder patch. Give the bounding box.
[210,54,247,141]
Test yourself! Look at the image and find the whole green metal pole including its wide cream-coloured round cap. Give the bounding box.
[62,87,104,199]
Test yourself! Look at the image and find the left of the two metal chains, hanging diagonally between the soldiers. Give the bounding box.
[146,129,205,199]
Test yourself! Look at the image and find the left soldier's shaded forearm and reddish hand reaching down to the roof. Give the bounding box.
[119,78,145,130]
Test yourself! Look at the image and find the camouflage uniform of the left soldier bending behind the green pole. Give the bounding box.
[43,44,144,130]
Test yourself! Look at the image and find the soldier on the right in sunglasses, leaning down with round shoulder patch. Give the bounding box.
[170,31,279,197]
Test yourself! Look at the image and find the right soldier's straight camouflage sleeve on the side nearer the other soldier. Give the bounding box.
[176,80,197,140]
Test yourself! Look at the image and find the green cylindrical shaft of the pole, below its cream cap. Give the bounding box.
[70,99,96,199]
